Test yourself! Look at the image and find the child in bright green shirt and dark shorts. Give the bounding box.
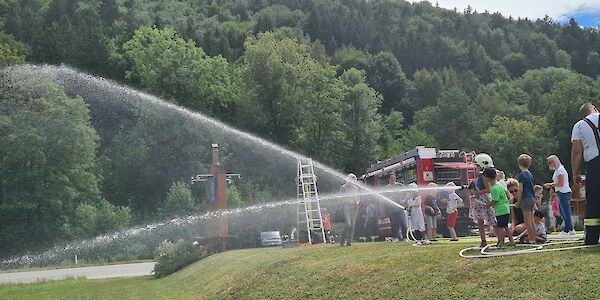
[483,168,515,247]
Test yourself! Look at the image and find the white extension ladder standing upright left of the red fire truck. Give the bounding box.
[297,158,325,244]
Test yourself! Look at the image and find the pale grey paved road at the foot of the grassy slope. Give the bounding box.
[0,262,154,284]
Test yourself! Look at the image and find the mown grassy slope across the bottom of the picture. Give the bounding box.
[0,243,600,299]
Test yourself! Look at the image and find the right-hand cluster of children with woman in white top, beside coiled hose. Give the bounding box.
[469,154,575,247]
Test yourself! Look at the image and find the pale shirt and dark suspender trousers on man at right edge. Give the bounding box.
[571,112,600,245]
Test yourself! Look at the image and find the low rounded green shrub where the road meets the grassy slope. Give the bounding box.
[154,240,203,278]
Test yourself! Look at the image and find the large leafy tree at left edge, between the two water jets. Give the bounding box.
[0,69,128,255]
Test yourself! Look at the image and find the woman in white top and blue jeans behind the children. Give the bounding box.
[544,155,575,235]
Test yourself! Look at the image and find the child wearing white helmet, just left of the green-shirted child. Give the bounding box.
[469,153,496,248]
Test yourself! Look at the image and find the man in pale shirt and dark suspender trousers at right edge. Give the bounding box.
[571,103,600,245]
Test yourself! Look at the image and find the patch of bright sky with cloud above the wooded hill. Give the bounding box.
[414,0,600,27]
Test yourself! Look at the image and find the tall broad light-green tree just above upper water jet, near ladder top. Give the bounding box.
[238,33,320,144]
